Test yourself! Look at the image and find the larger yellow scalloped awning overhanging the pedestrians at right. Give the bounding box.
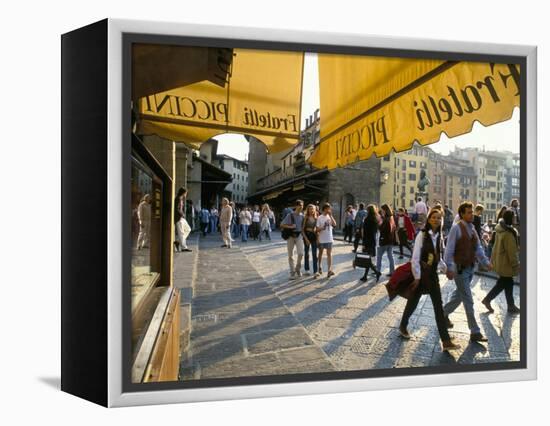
[310,54,520,169]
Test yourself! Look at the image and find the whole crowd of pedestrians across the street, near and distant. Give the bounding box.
[176,188,520,350]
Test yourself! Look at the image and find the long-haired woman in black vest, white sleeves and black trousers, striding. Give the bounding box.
[399,209,460,351]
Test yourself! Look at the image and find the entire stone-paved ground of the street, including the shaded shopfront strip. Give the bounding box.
[181,232,520,380]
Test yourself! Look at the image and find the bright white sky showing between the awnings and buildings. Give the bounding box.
[216,53,519,160]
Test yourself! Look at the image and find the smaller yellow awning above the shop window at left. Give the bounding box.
[137,49,304,152]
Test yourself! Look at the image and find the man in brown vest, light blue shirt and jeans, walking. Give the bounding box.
[443,202,493,342]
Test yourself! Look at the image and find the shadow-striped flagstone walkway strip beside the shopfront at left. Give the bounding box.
[180,236,335,380]
